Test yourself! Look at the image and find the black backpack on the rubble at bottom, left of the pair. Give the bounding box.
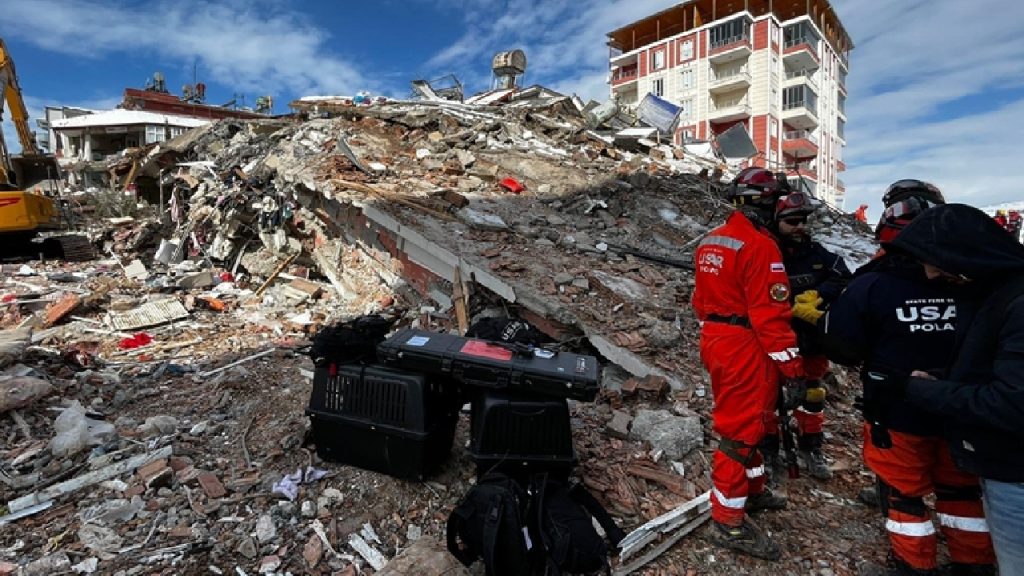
[446,472,536,576]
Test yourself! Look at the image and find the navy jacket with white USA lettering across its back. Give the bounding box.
[817,254,959,436]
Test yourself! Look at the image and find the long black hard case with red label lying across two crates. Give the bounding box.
[377,329,598,402]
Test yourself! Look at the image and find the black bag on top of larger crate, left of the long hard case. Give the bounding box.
[309,315,392,366]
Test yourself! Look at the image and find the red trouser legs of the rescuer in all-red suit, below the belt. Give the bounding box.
[700,327,779,526]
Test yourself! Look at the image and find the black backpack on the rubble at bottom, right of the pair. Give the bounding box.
[530,474,626,576]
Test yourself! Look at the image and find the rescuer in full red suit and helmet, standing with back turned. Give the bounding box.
[692,163,803,560]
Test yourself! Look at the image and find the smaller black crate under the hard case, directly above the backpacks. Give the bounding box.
[469,390,577,475]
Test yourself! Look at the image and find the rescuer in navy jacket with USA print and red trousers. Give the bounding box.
[794,180,994,575]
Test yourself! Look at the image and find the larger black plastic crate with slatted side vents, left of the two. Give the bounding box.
[306,365,459,479]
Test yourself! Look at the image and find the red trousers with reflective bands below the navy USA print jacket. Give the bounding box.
[864,423,995,570]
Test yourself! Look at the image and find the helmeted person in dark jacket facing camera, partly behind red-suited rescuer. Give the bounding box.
[761,192,853,482]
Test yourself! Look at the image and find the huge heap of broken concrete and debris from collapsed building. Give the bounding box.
[0,97,878,576]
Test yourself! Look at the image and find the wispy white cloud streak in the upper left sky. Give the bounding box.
[3,0,376,94]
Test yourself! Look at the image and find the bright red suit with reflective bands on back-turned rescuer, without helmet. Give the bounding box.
[692,211,803,526]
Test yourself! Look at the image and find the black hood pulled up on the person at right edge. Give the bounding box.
[883,204,1024,281]
